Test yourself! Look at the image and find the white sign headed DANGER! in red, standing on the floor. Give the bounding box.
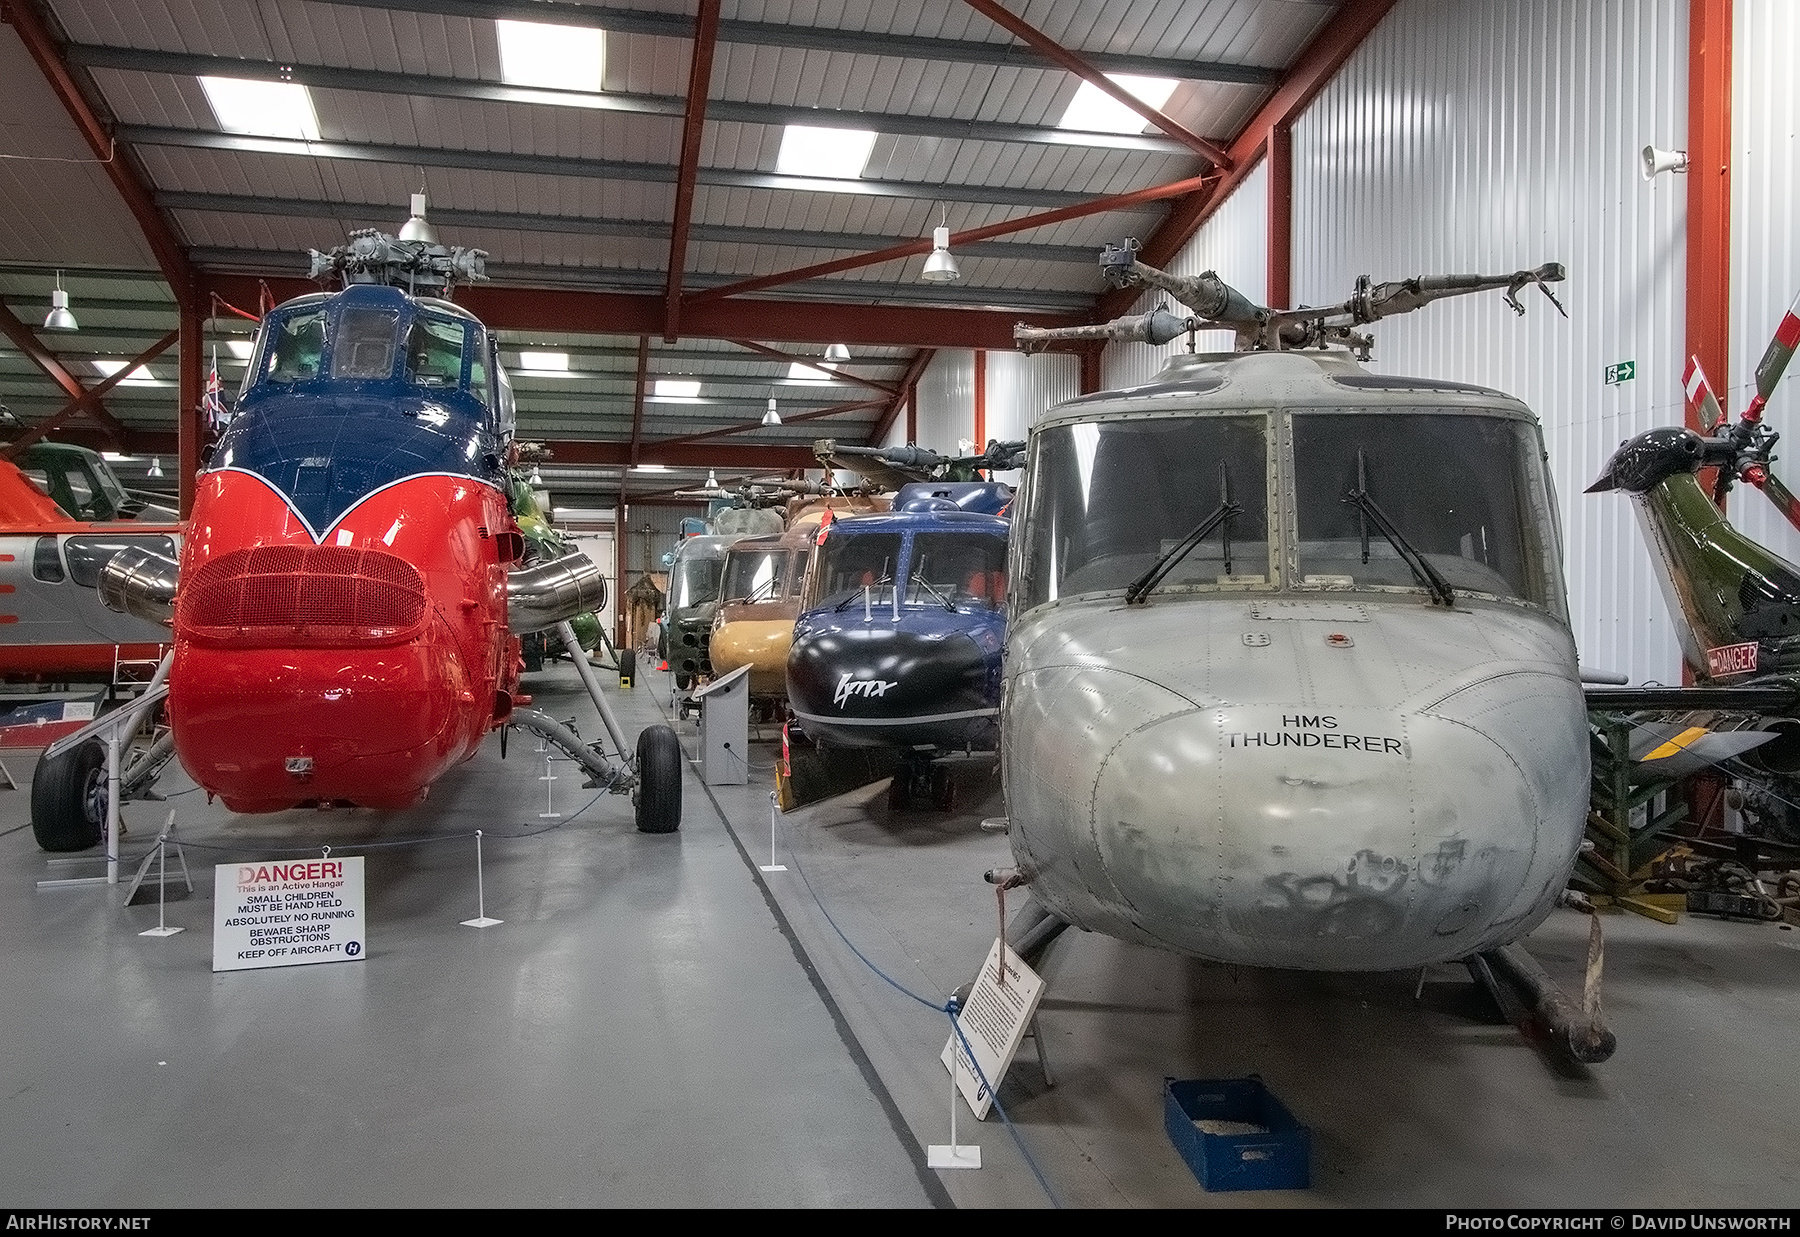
[212,855,369,971]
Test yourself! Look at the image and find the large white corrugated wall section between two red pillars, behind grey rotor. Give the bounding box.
[1292,0,1684,682]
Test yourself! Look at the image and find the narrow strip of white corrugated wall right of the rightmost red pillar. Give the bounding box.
[1714,0,1800,562]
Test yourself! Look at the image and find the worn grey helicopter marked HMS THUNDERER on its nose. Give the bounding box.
[988,241,1613,1061]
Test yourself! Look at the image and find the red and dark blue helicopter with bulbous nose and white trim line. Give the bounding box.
[34,222,680,848]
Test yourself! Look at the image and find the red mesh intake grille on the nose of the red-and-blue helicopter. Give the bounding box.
[176,546,427,648]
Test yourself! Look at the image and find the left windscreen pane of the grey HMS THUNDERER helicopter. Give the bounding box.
[1021,416,1269,609]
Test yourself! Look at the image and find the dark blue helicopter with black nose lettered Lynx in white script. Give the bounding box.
[788,481,1012,808]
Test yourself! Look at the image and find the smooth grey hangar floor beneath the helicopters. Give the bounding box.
[0,664,1800,1206]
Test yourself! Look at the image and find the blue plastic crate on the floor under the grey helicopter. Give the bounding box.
[1163,1075,1312,1190]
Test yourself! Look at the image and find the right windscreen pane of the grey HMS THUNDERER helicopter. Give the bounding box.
[1294,411,1561,607]
